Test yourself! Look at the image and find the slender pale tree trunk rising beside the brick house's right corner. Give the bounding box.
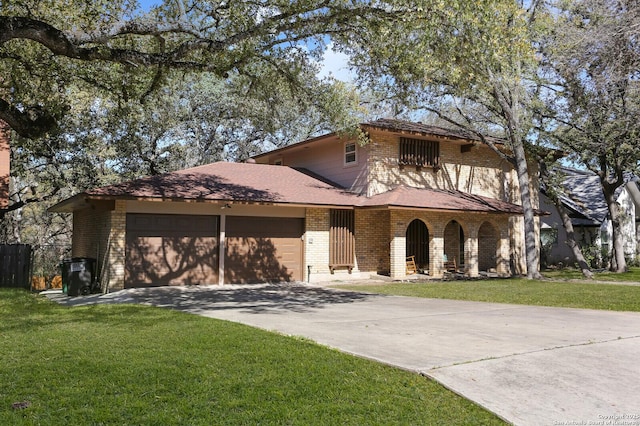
[513,140,542,280]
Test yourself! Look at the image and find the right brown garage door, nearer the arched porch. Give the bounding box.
[224,216,304,283]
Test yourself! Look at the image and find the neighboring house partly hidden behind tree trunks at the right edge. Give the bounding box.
[540,168,640,266]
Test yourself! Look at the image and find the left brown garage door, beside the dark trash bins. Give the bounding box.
[125,213,219,288]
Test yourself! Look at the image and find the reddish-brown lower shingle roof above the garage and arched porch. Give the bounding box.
[50,162,536,214]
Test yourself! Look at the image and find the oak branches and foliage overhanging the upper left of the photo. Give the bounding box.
[0,0,395,138]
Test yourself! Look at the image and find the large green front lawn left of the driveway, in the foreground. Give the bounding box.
[0,290,502,425]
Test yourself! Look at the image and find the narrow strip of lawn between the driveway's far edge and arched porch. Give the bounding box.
[334,272,640,312]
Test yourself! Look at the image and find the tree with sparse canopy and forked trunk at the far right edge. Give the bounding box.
[543,0,640,272]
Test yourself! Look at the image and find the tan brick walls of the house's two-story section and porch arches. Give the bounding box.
[305,127,538,279]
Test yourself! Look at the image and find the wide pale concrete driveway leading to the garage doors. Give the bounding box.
[50,285,640,425]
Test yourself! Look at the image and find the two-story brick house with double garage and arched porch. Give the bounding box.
[51,120,537,289]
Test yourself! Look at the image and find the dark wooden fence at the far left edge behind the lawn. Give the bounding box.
[0,244,33,290]
